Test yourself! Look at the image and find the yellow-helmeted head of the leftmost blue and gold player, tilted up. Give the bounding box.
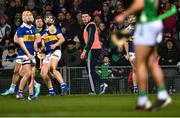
[22,11,34,25]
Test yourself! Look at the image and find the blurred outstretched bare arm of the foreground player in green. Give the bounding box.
[115,0,145,22]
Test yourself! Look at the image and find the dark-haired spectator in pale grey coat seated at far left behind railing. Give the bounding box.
[2,45,17,69]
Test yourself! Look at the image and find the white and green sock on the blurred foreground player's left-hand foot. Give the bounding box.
[137,91,148,106]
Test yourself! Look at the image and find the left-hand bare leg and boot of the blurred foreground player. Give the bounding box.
[135,45,152,110]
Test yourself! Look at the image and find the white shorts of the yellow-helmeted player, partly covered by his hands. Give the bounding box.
[16,55,36,65]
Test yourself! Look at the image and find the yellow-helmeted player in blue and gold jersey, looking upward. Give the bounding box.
[16,11,37,100]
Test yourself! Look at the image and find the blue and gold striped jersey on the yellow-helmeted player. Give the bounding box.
[17,23,36,56]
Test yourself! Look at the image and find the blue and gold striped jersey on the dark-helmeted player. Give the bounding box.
[42,28,61,54]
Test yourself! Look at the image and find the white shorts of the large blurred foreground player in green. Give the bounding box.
[134,20,163,46]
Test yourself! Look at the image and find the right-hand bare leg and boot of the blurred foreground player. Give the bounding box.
[148,48,171,110]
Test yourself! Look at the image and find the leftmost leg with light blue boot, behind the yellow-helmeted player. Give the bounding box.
[1,62,21,96]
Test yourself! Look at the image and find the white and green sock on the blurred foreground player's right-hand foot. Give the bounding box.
[157,85,168,100]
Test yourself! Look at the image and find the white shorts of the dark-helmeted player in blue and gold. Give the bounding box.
[43,49,62,63]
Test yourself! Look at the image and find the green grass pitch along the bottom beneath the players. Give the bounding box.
[0,94,180,117]
